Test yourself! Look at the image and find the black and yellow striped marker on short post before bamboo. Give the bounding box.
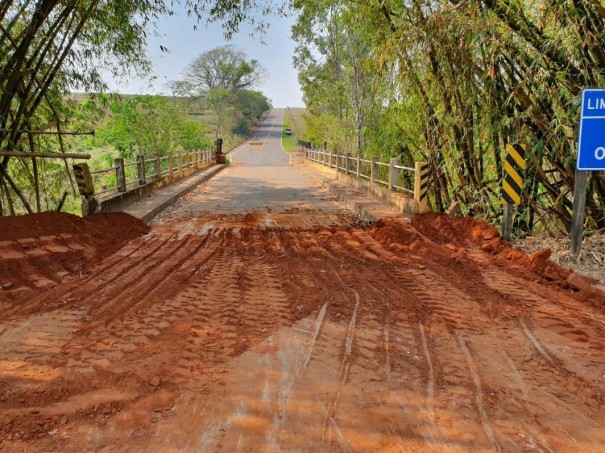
[501,145,527,241]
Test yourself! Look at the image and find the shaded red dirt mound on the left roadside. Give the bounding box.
[0,212,148,301]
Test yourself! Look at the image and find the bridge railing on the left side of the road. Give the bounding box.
[90,149,215,198]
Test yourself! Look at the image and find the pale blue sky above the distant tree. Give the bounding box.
[107,9,304,107]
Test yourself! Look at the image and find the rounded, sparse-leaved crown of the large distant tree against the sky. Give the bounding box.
[185,45,265,95]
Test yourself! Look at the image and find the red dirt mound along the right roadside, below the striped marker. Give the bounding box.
[372,212,605,306]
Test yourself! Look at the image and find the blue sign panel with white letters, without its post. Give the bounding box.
[578,88,605,171]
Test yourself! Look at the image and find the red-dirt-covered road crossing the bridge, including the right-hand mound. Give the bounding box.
[0,107,605,452]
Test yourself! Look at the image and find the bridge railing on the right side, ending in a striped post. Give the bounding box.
[298,140,428,212]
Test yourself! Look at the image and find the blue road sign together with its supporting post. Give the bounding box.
[571,88,605,257]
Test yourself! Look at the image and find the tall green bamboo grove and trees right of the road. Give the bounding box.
[293,0,605,233]
